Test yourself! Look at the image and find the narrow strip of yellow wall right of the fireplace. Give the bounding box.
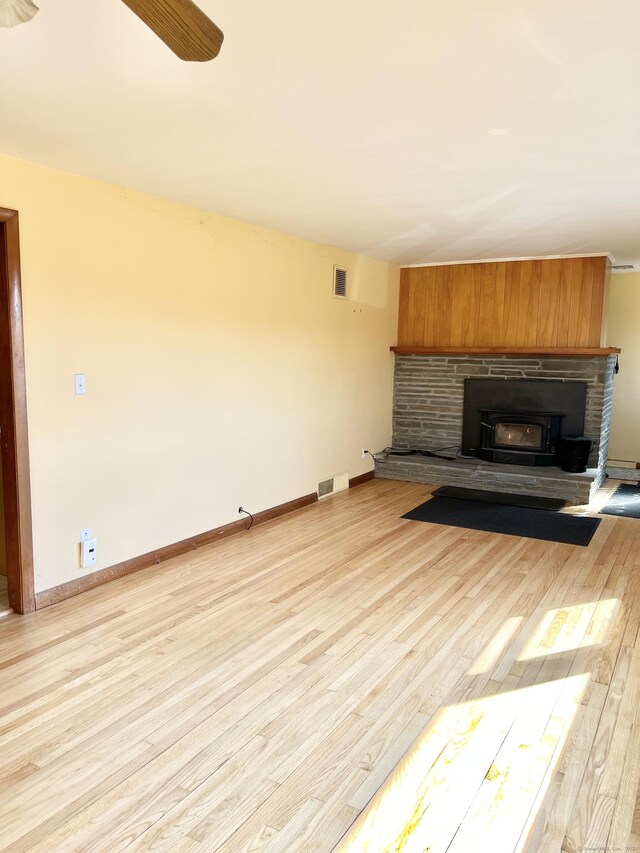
[607,273,640,465]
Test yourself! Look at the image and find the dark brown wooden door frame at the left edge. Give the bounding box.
[0,207,36,613]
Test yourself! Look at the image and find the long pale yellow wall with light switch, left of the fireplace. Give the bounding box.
[0,157,399,591]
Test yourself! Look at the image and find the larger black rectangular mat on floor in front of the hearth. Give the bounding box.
[402,497,600,545]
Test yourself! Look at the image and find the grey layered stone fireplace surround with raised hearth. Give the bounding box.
[375,353,616,504]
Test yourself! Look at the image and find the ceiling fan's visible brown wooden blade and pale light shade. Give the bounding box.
[0,0,224,62]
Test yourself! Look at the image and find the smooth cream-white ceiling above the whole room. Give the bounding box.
[0,0,640,264]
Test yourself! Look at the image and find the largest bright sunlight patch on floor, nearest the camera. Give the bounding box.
[338,673,590,853]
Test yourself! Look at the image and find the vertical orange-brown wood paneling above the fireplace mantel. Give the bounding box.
[398,257,607,348]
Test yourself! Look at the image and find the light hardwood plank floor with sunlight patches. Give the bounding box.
[0,480,640,853]
